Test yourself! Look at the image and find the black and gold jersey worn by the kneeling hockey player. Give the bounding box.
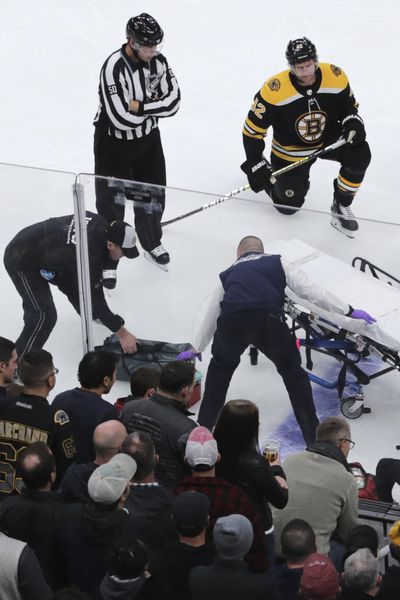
[243,63,357,162]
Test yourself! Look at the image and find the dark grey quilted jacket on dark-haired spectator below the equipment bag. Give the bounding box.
[121,393,196,488]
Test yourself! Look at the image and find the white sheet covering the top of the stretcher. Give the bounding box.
[265,239,400,352]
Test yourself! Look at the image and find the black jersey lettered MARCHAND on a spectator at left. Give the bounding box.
[0,394,76,500]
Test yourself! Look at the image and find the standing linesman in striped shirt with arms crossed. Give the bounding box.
[94,13,180,287]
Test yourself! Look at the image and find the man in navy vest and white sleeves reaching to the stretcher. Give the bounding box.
[194,236,373,444]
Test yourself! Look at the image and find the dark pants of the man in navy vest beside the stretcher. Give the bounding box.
[198,311,318,445]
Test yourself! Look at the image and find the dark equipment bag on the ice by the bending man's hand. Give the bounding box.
[95,334,193,381]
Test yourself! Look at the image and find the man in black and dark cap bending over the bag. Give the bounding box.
[4,212,138,358]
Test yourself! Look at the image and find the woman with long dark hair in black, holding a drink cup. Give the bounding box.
[214,400,288,563]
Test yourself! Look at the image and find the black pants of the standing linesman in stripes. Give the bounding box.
[94,127,167,251]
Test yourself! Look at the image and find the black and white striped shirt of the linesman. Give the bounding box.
[94,45,181,140]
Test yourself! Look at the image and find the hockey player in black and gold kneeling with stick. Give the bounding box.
[241,37,371,238]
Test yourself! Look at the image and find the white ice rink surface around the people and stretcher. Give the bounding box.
[0,0,400,471]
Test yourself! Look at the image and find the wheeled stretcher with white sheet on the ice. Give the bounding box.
[260,239,400,419]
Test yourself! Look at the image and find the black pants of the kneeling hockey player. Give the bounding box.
[267,142,371,214]
